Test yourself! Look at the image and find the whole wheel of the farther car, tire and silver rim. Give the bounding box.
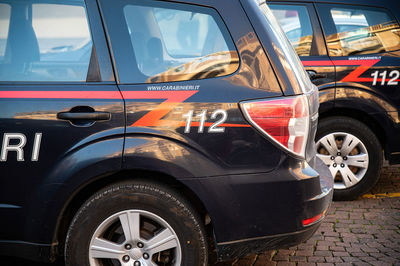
[316,116,383,200]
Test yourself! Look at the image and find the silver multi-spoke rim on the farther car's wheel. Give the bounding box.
[316,132,369,189]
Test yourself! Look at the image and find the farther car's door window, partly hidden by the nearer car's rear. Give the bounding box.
[268,4,313,56]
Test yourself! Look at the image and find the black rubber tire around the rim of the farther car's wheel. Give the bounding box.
[315,116,383,200]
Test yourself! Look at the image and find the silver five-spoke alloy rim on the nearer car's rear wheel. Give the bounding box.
[89,210,182,266]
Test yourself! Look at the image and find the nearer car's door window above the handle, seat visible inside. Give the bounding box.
[0,0,92,81]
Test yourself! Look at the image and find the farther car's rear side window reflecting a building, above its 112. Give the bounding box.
[320,5,400,56]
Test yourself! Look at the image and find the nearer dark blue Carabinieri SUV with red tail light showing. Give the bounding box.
[0,0,333,265]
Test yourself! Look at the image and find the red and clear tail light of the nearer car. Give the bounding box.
[241,95,310,157]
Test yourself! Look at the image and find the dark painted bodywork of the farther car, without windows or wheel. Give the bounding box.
[268,0,400,164]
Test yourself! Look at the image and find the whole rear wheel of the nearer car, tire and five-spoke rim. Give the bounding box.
[65,181,208,266]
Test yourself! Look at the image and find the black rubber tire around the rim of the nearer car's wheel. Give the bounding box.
[65,181,208,266]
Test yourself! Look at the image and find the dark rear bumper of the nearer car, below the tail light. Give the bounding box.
[182,157,333,260]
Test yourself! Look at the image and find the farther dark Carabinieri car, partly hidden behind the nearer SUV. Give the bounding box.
[268,0,400,200]
